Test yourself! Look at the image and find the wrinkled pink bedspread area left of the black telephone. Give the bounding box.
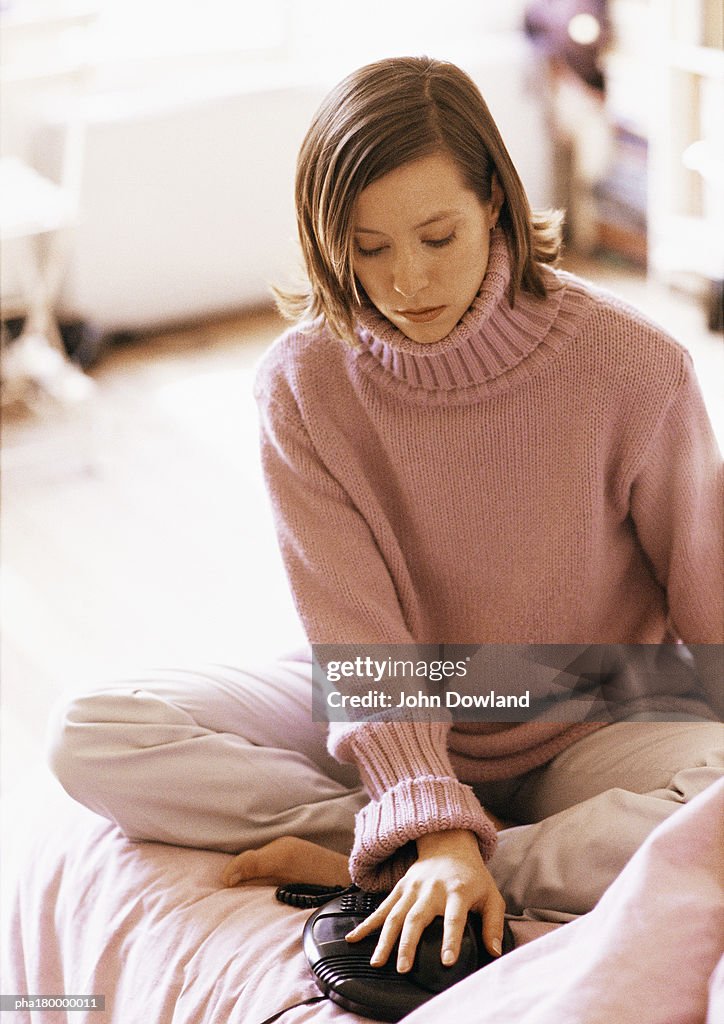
[2,778,361,1024]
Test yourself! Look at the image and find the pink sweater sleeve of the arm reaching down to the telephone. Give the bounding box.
[257,362,496,891]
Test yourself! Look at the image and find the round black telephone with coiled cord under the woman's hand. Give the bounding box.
[278,886,513,1021]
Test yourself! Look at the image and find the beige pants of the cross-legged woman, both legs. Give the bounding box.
[50,656,724,913]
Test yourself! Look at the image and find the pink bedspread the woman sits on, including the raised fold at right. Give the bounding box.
[2,783,724,1024]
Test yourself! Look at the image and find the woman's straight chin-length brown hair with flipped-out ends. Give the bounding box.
[275,57,562,341]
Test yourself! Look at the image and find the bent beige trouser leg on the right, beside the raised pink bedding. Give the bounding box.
[475,722,724,914]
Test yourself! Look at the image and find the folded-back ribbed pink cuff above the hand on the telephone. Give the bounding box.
[349,775,497,892]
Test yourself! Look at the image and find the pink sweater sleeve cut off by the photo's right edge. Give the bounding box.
[631,354,724,716]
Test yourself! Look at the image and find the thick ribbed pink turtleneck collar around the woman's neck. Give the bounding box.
[356,228,566,392]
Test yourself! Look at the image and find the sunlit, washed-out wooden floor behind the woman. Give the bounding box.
[1,263,724,792]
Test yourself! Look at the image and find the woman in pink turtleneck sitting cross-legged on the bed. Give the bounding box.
[48,58,724,971]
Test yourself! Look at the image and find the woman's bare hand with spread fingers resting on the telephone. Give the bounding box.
[347,830,505,972]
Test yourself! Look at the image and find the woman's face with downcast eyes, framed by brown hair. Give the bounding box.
[352,153,503,345]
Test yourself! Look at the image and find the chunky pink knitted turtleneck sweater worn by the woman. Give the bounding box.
[257,229,724,889]
